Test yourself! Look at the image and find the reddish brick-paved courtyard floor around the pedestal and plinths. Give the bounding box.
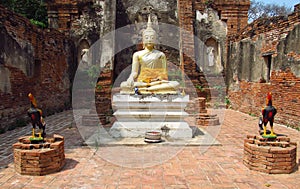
[0,110,300,189]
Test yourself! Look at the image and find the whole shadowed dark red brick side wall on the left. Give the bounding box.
[0,6,76,129]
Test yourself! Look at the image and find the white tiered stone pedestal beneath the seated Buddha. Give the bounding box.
[109,94,193,138]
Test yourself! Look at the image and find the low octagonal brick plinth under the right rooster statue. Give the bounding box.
[243,135,297,174]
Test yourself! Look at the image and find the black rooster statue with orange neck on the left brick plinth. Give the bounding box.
[27,93,46,141]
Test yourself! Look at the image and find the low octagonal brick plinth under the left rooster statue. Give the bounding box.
[13,135,65,175]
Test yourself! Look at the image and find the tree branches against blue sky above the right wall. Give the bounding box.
[248,0,292,22]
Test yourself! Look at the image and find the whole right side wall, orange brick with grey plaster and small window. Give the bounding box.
[226,5,300,127]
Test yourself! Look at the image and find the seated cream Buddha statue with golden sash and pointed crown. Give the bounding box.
[121,16,179,94]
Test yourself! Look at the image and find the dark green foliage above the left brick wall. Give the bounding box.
[0,0,48,27]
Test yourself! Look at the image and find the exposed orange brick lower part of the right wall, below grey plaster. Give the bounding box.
[229,70,300,127]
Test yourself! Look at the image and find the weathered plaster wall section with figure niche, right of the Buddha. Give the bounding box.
[195,8,227,74]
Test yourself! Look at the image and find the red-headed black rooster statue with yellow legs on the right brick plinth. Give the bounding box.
[262,92,277,138]
